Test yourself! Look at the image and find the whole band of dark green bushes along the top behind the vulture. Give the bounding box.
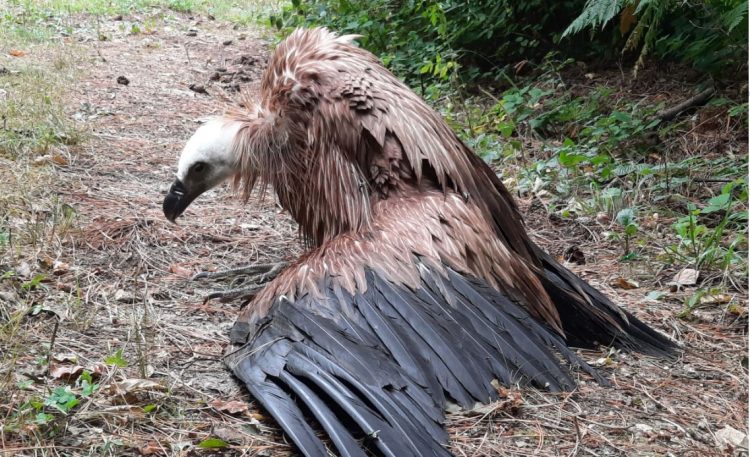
[270,0,747,83]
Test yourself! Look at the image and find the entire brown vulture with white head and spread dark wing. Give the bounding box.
[164,29,675,457]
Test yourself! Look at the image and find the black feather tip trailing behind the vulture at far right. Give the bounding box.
[536,247,678,358]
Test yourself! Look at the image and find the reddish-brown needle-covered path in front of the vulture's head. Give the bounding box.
[40,13,297,455]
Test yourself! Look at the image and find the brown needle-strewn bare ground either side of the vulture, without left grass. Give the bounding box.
[1,10,748,456]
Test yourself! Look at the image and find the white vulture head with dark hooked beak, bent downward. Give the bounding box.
[162,118,241,222]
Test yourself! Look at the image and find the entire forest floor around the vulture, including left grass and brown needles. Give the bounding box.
[0,6,748,456]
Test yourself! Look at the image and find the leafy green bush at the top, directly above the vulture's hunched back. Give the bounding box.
[269,0,583,81]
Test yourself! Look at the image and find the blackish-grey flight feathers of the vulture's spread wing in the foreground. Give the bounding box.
[226,257,601,457]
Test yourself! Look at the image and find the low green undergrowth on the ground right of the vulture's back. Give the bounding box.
[448,63,747,278]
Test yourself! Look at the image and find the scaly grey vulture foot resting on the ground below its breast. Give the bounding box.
[190,262,287,303]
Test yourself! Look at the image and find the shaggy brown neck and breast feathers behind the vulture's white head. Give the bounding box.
[231,111,372,247]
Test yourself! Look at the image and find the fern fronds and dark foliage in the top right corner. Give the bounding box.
[563,0,748,74]
